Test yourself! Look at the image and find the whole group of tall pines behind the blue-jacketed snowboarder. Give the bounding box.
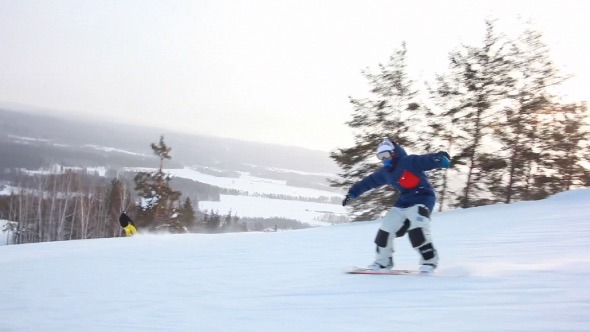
[331,20,590,220]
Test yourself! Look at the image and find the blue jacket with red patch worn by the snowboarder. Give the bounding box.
[348,143,441,211]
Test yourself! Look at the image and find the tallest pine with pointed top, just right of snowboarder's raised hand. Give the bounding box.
[434,21,511,208]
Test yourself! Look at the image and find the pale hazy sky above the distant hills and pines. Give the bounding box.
[0,0,590,151]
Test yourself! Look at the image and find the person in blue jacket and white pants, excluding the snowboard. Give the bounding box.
[342,139,451,272]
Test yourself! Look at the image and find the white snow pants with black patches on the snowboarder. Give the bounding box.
[375,204,438,267]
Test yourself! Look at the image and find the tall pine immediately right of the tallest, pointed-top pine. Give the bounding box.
[495,29,563,203]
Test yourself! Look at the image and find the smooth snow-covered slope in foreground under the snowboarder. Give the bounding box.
[0,190,590,332]
